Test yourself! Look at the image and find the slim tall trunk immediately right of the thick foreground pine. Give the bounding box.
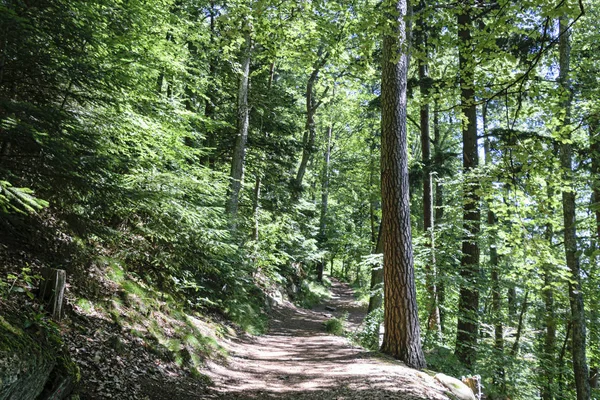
[416,1,441,342]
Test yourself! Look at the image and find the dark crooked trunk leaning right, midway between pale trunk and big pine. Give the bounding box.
[292,49,329,200]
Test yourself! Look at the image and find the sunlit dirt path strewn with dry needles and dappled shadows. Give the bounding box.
[203,281,448,400]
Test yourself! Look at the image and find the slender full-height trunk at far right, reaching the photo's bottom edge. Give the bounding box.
[559,17,590,400]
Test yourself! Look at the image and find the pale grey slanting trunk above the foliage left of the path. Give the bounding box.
[227,28,252,227]
